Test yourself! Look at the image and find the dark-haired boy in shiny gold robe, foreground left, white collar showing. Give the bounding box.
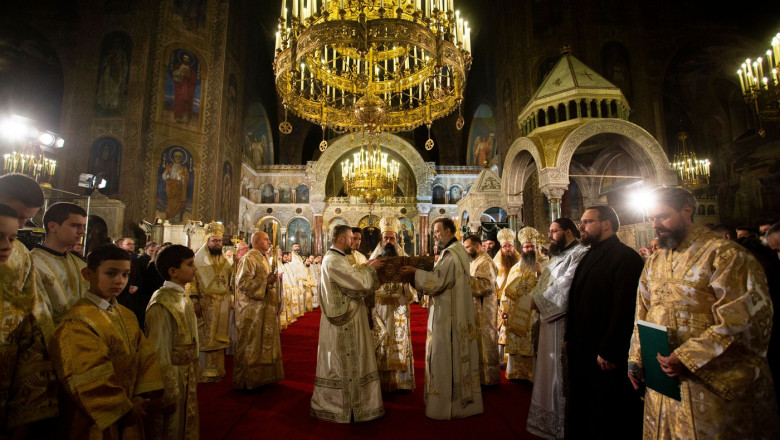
[49,245,162,439]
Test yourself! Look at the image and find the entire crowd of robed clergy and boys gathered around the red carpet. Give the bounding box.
[0,168,780,439]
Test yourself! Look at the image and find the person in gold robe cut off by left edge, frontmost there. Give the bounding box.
[0,201,57,436]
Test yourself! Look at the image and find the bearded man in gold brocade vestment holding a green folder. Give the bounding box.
[628,188,780,439]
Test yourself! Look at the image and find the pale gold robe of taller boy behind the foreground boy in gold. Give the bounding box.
[30,246,89,326]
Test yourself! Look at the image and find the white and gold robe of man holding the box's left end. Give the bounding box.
[311,248,385,423]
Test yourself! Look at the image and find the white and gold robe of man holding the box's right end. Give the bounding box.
[414,241,483,420]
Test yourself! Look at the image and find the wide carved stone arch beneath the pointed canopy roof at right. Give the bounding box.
[555,119,677,185]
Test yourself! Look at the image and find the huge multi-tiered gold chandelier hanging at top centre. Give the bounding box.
[274,0,472,150]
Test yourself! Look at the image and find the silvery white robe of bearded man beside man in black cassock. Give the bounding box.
[526,240,588,439]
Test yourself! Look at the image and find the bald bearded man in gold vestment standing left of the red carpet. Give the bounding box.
[187,222,232,382]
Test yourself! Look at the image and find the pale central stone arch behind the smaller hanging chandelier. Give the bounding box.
[306,134,433,202]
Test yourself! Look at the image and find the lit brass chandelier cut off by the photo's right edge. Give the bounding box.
[737,33,780,137]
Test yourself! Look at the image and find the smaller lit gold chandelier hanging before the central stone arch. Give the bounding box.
[341,134,400,206]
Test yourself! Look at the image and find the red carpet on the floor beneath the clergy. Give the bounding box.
[198,304,537,440]
